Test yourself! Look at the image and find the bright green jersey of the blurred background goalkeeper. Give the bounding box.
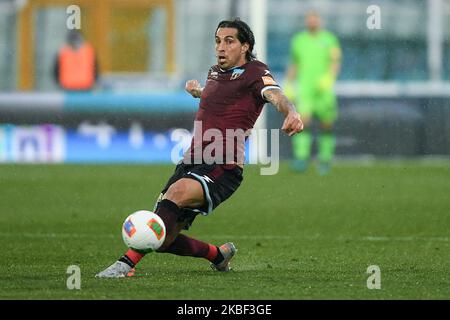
[290,30,340,87]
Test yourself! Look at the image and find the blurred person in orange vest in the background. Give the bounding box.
[54,30,98,91]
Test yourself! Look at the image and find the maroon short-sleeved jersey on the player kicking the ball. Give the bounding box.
[183,60,280,164]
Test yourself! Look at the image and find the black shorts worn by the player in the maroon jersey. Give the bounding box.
[155,162,243,229]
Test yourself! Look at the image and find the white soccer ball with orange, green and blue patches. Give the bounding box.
[122,210,166,253]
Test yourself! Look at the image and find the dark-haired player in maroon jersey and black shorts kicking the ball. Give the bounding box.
[96,19,303,277]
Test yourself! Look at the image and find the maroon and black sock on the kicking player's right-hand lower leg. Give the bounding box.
[164,233,223,263]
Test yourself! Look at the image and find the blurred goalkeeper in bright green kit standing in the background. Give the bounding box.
[285,11,341,174]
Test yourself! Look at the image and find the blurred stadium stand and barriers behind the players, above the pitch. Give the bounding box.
[0,0,450,161]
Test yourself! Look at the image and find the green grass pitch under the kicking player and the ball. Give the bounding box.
[0,162,450,300]
